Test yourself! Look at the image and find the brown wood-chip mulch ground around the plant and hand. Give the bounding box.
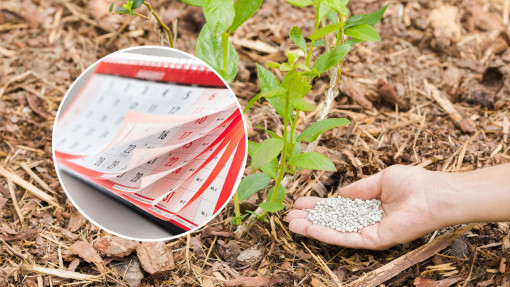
[0,0,510,286]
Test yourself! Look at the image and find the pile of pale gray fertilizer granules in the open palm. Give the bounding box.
[307,197,383,232]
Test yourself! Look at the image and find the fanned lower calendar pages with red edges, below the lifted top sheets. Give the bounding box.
[65,123,246,230]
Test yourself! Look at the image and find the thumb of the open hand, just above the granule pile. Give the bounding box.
[338,170,384,200]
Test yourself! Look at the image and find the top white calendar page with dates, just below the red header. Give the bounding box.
[54,74,235,157]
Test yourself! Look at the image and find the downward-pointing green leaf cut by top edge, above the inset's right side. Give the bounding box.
[202,0,235,37]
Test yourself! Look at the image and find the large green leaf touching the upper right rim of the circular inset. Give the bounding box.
[196,24,239,83]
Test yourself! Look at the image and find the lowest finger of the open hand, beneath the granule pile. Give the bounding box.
[306,225,366,251]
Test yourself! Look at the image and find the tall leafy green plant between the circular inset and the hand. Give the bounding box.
[232,0,388,224]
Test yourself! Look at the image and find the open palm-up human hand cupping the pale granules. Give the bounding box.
[285,165,448,250]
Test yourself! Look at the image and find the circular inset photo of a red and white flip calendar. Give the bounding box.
[53,46,247,241]
